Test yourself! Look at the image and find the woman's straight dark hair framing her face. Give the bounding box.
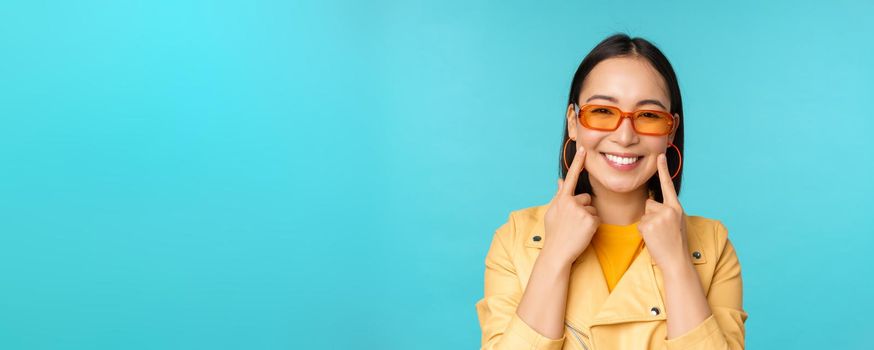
[558,34,685,202]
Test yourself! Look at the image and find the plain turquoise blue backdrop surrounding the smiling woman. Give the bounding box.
[0,1,874,349]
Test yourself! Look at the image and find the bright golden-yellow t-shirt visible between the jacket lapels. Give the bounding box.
[592,222,644,292]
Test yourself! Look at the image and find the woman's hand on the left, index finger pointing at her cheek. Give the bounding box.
[540,147,601,264]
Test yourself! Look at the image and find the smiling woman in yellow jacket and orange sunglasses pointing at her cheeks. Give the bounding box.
[476,34,747,349]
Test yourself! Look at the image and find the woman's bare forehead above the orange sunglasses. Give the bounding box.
[579,57,671,108]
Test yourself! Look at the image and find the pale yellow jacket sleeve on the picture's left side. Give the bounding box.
[476,214,565,350]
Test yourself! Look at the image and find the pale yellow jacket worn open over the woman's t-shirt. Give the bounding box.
[476,204,747,350]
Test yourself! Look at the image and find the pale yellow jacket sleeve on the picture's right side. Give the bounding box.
[667,222,748,350]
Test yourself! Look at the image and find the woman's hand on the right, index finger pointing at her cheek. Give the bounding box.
[637,153,690,269]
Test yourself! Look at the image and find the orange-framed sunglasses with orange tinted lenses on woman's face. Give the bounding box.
[574,103,675,136]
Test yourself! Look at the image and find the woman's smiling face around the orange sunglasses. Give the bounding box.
[567,57,679,194]
